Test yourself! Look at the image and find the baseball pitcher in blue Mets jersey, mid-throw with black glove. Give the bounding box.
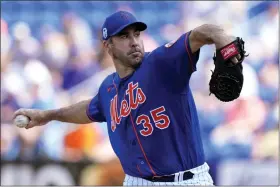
[14,11,246,185]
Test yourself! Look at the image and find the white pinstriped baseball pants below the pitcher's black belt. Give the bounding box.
[123,163,213,186]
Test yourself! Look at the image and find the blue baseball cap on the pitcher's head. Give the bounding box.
[102,11,147,40]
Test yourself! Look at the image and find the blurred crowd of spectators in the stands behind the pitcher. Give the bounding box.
[1,1,279,185]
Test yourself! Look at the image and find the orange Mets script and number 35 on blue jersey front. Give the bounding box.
[110,82,170,136]
